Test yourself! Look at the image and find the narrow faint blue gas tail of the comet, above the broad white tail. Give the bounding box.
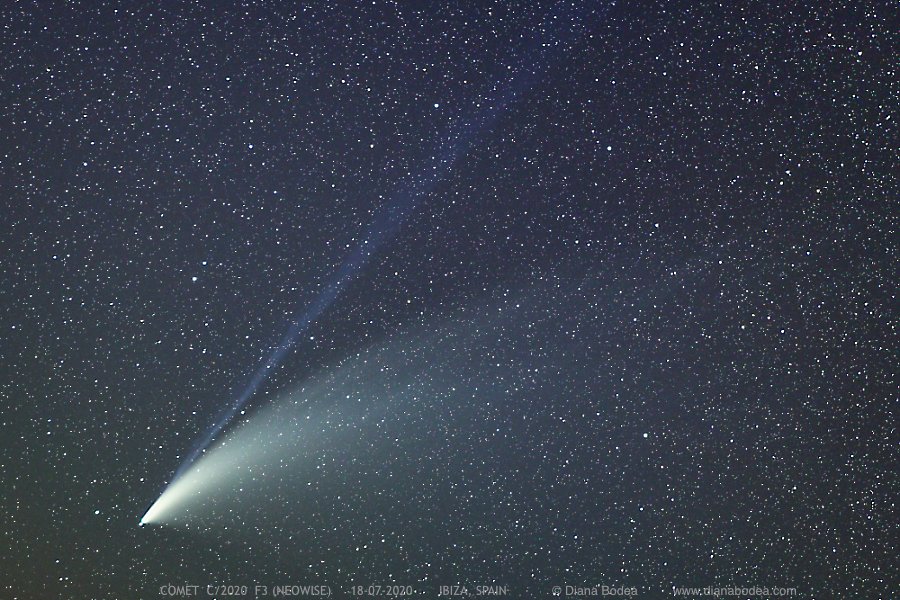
[172,5,604,481]
